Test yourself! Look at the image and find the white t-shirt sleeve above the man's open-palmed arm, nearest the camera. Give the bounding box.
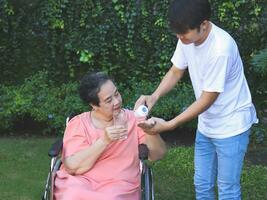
[203,56,232,93]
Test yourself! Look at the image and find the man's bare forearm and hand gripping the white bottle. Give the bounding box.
[134,65,185,110]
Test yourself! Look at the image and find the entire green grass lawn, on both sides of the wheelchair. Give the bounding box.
[0,138,267,200]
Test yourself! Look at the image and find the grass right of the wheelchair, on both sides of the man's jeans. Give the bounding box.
[153,147,267,200]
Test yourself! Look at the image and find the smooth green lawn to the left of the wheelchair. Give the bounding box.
[0,138,54,200]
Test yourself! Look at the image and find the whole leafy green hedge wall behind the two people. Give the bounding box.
[0,0,267,138]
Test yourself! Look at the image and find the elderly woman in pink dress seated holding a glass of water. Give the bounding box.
[54,72,166,200]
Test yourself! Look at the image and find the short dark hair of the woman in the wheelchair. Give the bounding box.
[78,72,112,106]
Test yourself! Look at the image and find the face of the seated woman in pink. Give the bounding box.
[93,80,122,118]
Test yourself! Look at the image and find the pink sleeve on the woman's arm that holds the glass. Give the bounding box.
[63,116,90,158]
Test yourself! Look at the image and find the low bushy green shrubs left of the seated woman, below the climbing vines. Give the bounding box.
[0,71,85,134]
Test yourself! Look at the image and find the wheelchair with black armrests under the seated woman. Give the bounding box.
[42,115,154,200]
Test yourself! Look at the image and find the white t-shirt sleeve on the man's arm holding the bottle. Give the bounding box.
[171,40,188,70]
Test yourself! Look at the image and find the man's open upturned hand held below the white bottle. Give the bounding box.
[138,117,171,135]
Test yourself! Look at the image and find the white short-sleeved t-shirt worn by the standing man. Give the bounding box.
[171,24,258,138]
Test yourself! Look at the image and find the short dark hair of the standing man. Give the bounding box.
[169,0,211,34]
